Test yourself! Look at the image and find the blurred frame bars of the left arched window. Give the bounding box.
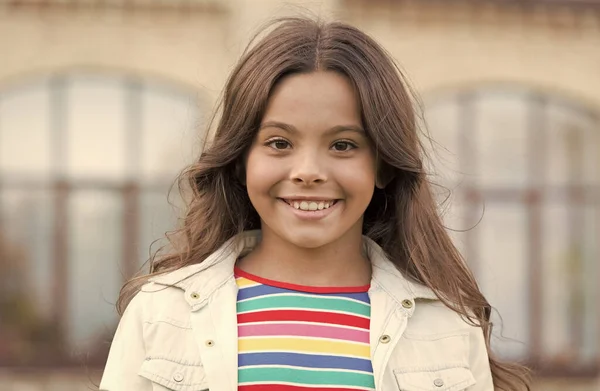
[0,70,199,368]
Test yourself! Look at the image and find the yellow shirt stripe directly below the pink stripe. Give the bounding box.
[238,338,371,358]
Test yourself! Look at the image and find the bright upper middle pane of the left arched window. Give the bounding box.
[66,76,127,180]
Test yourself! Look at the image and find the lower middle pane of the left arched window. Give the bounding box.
[68,191,123,349]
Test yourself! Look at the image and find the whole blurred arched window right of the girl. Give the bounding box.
[425,87,600,374]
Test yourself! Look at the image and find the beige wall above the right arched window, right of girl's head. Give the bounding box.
[347,1,600,111]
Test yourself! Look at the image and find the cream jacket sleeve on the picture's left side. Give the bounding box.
[100,293,152,391]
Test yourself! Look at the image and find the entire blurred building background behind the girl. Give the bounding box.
[0,0,600,391]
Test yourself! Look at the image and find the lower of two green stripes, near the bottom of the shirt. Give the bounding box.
[238,367,375,389]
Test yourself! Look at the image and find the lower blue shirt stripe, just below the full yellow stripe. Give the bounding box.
[238,353,373,372]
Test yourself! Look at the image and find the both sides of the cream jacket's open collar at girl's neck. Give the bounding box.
[149,230,437,304]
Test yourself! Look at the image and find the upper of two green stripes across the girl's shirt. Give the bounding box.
[237,295,371,316]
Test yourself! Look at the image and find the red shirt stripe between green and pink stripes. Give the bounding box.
[237,310,370,330]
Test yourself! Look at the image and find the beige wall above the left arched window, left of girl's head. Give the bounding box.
[0,0,335,99]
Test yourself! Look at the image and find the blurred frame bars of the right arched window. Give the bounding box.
[425,85,600,378]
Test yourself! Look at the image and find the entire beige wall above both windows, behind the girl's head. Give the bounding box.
[0,0,600,108]
